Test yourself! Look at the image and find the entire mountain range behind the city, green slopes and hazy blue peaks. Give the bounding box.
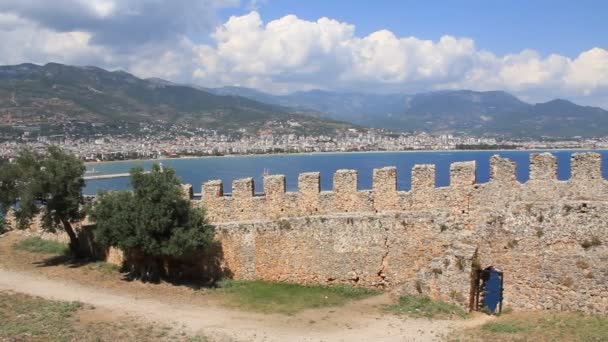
[0,63,608,137]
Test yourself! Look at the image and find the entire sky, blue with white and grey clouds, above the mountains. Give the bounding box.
[0,0,608,108]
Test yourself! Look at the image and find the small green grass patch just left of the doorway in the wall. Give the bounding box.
[384,295,467,318]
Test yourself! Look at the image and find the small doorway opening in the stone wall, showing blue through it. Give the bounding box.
[471,266,504,314]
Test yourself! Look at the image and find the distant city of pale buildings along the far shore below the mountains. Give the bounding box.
[0,124,608,162]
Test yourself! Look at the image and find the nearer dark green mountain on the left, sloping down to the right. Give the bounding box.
[0,63,352,133]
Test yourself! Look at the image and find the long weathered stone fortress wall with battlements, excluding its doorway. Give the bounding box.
[185,153,608,313]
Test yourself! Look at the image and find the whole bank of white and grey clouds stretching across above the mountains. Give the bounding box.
[0,7,608,107]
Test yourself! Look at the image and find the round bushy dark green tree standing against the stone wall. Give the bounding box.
[90,165,213,281]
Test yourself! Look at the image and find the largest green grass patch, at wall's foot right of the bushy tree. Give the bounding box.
[219,280,379,314]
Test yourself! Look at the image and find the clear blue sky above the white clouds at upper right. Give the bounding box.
[222,0,608,57]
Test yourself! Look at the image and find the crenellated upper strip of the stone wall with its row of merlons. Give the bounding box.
[197,153,608,223]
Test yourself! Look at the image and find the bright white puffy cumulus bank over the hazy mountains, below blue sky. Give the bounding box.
[194,12,608,105]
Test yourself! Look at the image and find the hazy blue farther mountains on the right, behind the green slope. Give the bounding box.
[212,87,608,137]
